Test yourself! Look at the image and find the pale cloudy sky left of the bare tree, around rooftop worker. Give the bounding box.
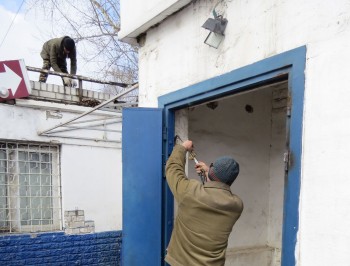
[0,0,101,89]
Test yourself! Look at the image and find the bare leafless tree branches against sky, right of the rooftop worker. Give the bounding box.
[27,0,138,95]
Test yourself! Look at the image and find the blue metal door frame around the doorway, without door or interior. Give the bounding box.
[158,46,306,266]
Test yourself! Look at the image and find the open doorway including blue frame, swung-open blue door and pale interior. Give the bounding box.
[122,46,306,266]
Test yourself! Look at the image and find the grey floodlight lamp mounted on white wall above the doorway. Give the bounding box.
[202,16,228,49]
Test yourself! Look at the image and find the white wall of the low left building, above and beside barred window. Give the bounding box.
[0,96,122,232]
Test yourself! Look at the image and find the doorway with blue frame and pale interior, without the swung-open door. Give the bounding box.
[158,46,306,266]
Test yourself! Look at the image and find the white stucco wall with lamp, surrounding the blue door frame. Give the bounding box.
[121,0,350,266]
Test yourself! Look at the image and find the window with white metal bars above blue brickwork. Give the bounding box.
[0,140,62,233]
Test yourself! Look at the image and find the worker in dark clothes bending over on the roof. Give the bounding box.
[39,36,77,86]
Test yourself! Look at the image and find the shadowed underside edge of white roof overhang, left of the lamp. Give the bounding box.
[118,0,192,44]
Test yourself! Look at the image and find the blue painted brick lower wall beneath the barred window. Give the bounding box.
[0,231,122,266]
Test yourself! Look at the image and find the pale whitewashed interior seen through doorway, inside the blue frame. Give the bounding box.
[175,80,289,266]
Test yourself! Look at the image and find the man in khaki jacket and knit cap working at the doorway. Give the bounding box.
[165,140,243,266]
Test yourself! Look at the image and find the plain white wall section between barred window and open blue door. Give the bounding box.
[61,145,122,232]
